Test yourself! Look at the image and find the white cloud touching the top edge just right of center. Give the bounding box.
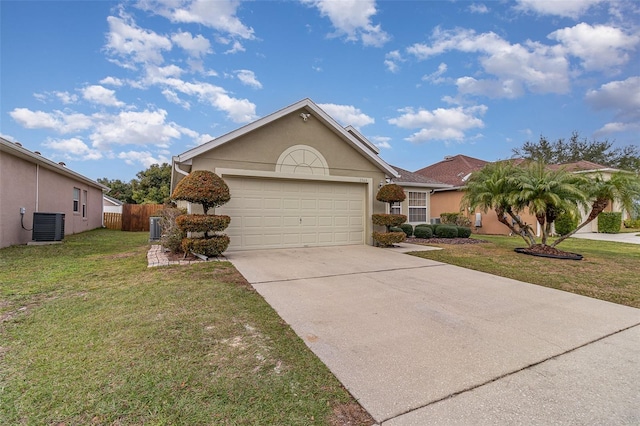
[303,0,390,47]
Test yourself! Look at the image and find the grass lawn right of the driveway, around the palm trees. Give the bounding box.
[412,235,640,308]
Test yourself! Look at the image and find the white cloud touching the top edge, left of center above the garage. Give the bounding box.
[136,0,255,40]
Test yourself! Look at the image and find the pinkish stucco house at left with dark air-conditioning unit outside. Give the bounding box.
[0,138,108,247]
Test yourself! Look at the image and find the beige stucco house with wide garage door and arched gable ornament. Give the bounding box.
[171,99,448,250]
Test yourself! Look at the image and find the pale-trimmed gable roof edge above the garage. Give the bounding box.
[173,98,398,177]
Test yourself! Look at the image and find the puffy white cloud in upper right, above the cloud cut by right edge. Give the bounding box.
[548,22,640,70]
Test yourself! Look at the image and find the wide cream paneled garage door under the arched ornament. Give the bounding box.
[216,177,365,250]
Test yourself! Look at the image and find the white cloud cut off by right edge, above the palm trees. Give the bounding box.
[585,76,640,134]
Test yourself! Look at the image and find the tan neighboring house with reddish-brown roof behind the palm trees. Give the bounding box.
[415,155,621,235]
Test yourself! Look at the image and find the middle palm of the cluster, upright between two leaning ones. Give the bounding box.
[511,161,587,245]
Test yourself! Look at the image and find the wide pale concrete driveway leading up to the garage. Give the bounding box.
[227,246,640,426]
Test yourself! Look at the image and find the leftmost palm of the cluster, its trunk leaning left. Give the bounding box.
[462,161,536,246]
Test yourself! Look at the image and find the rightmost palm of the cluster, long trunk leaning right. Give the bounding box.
[551,171,640,247]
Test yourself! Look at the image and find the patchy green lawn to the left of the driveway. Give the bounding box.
[0,230,371,425]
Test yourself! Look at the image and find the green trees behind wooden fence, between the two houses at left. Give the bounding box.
[98,163,171,204]
